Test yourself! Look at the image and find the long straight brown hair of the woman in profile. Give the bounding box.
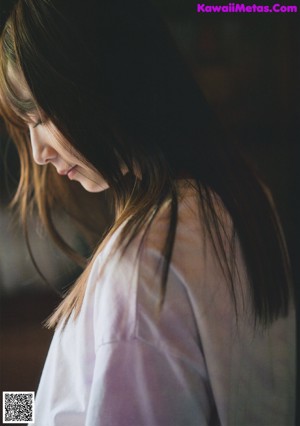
[0,0,290,326]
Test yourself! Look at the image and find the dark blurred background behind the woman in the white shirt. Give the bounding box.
[0,0,300,418]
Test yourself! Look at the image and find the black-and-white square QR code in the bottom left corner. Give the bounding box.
[2,392,34,424]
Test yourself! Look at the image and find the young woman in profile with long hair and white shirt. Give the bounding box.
[0,0,295,426]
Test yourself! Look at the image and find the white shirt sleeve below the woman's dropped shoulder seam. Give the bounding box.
[86,338,216,426]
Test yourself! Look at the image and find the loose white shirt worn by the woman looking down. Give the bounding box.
[35,186,295,426]
